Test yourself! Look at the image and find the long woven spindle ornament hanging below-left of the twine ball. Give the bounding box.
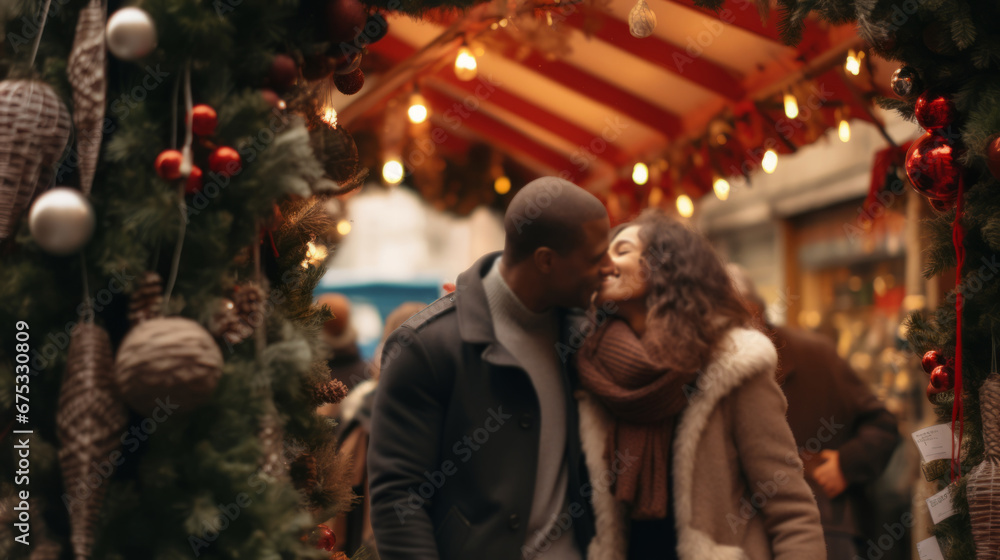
[56,323,128,560]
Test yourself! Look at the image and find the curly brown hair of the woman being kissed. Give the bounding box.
[612,209,750,371]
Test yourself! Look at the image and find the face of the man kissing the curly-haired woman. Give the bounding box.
[549,218,611,308]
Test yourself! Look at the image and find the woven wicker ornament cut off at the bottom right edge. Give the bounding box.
[966,373,1000,560]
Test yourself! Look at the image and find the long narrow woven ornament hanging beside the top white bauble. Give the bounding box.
[66,0,108,194]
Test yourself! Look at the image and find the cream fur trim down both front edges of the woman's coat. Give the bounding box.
[576,328,778,560]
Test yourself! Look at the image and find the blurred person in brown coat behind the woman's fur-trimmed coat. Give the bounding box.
[727,264,900,560]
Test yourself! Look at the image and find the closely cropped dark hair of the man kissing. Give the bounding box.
[503,177,608,263]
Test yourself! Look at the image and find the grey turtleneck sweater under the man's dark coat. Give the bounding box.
[483,258,582,560]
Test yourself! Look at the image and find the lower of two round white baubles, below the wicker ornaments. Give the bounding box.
[28,187,94,256]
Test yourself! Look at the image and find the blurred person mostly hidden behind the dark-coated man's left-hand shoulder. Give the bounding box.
[330,301,427,560]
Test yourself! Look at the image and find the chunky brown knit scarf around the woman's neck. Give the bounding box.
[577,319,697,519]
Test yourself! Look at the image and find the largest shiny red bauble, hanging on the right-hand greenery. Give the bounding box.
[906,132,962,201]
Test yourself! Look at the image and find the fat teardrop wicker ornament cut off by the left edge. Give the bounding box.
[0,80,70,239]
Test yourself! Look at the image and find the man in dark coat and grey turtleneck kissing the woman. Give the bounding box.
[368,177,610,560]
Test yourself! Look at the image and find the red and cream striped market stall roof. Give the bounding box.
[337,0,870,193]
